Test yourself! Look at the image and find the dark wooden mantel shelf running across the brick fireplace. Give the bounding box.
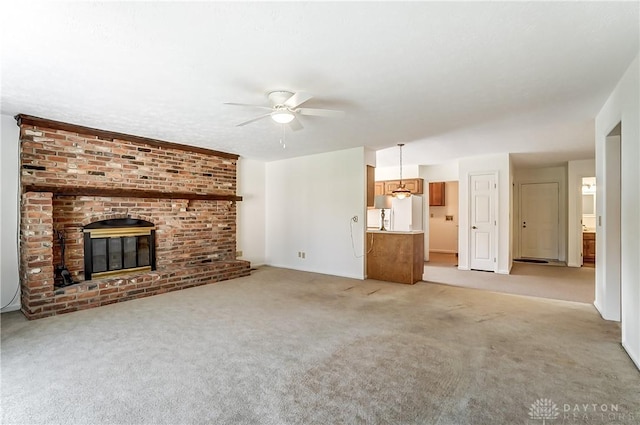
[23,185,242,202]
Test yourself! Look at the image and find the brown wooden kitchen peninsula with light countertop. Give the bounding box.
[367,230,424,284]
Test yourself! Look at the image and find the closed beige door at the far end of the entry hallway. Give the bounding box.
[520,183,560,260]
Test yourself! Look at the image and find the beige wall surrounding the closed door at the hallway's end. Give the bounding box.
[513,166,567,261]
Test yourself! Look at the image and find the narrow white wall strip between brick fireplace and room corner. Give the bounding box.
[236,158,266,266]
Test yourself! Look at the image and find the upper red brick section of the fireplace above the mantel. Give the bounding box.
[20,125,236,195]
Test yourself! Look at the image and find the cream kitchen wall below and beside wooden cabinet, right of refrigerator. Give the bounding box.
[427,181,460,253]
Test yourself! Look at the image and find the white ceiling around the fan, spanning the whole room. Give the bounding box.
[0,1,640,166]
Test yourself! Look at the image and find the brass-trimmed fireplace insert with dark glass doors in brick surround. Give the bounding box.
[84,218,155,280]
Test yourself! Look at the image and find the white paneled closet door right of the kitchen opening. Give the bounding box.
[469,174,497,271]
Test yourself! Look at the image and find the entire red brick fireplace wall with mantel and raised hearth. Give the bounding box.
[16,115,250,319]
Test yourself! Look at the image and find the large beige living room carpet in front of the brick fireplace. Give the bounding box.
[1,267,640,424]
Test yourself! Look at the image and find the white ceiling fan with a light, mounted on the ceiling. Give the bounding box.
[224,90,344,131]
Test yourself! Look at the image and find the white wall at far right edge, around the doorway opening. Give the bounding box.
[594,52,640,368]
